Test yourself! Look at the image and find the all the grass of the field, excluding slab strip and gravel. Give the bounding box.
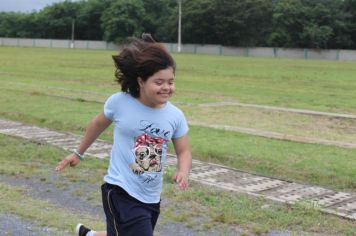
[0,47,356,235]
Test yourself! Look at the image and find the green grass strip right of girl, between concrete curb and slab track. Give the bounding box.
[190,127,356,191]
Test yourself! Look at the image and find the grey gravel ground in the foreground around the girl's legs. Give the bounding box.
[0,175,242,236]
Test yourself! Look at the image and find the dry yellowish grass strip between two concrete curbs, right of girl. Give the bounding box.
[179,105,356,145]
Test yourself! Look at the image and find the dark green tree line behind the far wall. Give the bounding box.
[0,0,356,49]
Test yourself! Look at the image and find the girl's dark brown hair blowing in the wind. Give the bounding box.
[112,34,176,98]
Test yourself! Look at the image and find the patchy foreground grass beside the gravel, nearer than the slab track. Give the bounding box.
[0,135,356,235]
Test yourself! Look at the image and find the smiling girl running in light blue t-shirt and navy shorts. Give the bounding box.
[56,34,192,236]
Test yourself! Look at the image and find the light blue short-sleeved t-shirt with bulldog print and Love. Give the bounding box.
[104,92,188,203]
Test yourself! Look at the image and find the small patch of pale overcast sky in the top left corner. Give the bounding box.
[0,0,64,12]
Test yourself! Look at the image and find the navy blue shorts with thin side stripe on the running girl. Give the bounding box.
[101,183,160,236]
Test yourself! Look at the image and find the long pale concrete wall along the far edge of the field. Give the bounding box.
[0,38,356,61]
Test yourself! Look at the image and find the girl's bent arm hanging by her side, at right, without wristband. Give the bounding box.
[172,135,192,190]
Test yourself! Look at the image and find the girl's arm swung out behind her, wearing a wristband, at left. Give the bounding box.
[56,112,112,171]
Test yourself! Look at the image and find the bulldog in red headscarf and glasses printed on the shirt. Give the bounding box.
[130,133,167,175]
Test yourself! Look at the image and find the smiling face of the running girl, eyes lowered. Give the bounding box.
[138,67,175,108]
